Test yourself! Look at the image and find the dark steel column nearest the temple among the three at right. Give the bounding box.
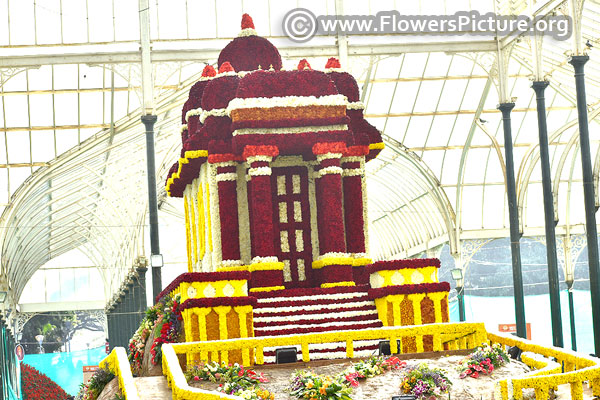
[498,103,527,338]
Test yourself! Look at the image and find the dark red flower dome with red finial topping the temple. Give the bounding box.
[218,14,281,71]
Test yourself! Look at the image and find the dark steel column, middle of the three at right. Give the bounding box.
[531,81,563,347]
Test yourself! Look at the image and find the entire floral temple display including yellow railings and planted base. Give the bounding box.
[92,14,600,400]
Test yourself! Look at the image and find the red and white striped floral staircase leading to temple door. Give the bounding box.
[253,285,383,363]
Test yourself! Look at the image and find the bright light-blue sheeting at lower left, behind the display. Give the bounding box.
[23,346,106,396]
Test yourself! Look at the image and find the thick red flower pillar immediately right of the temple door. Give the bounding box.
[312,143,354,288]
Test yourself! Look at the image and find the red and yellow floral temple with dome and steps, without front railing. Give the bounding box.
[161,15,450,365]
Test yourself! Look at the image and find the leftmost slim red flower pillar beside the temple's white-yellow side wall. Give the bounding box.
[217,161,241,267]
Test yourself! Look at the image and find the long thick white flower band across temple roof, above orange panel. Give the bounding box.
[227,94,348,112]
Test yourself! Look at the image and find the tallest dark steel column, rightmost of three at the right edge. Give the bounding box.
[569,56,600,356]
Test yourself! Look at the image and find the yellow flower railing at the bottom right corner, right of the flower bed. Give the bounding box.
[487,333,600,400]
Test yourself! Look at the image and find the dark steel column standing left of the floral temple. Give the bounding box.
[142,115,162,298]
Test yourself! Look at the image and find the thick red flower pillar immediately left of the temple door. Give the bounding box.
[243,146,285,292]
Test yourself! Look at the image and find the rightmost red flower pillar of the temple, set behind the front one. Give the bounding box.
[342,153,370,285]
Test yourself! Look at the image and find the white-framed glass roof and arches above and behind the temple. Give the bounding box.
[0,0,600,308]
